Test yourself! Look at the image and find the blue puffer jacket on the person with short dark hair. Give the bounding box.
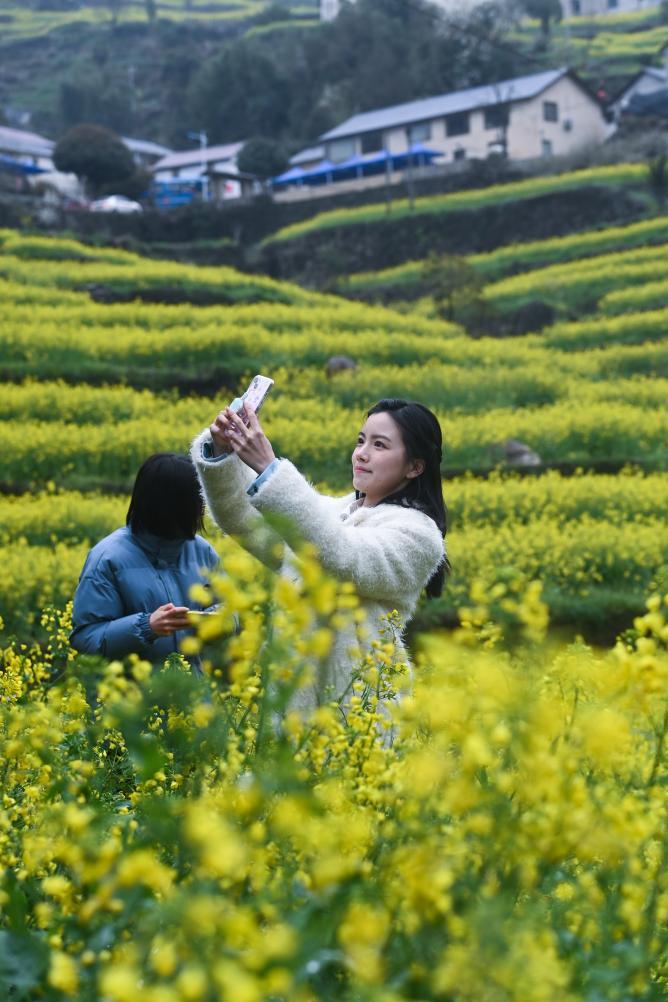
[70,526,218,661]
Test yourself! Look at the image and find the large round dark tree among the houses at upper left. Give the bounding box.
[53,124,135,191]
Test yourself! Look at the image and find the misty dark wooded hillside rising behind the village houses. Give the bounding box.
[5,0,668,152]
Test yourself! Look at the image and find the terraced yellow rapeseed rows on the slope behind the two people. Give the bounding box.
[0,205,668,633]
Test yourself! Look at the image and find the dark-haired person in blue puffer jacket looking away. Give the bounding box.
[70,452,218,661]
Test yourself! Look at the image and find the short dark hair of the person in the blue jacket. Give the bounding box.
[125,452,204,539]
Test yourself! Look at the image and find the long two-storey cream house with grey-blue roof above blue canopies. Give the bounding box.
[316,67,614,164]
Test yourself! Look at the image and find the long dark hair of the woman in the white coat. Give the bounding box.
[367,397,451,598]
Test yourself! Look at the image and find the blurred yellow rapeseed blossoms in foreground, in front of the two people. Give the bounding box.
[0,541,668,1002]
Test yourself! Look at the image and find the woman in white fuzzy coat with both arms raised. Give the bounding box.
[191,400,448,705]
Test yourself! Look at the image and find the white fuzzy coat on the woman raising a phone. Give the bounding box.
[191,430,445,706]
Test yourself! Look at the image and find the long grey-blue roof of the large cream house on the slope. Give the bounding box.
[319,66,569,140]
